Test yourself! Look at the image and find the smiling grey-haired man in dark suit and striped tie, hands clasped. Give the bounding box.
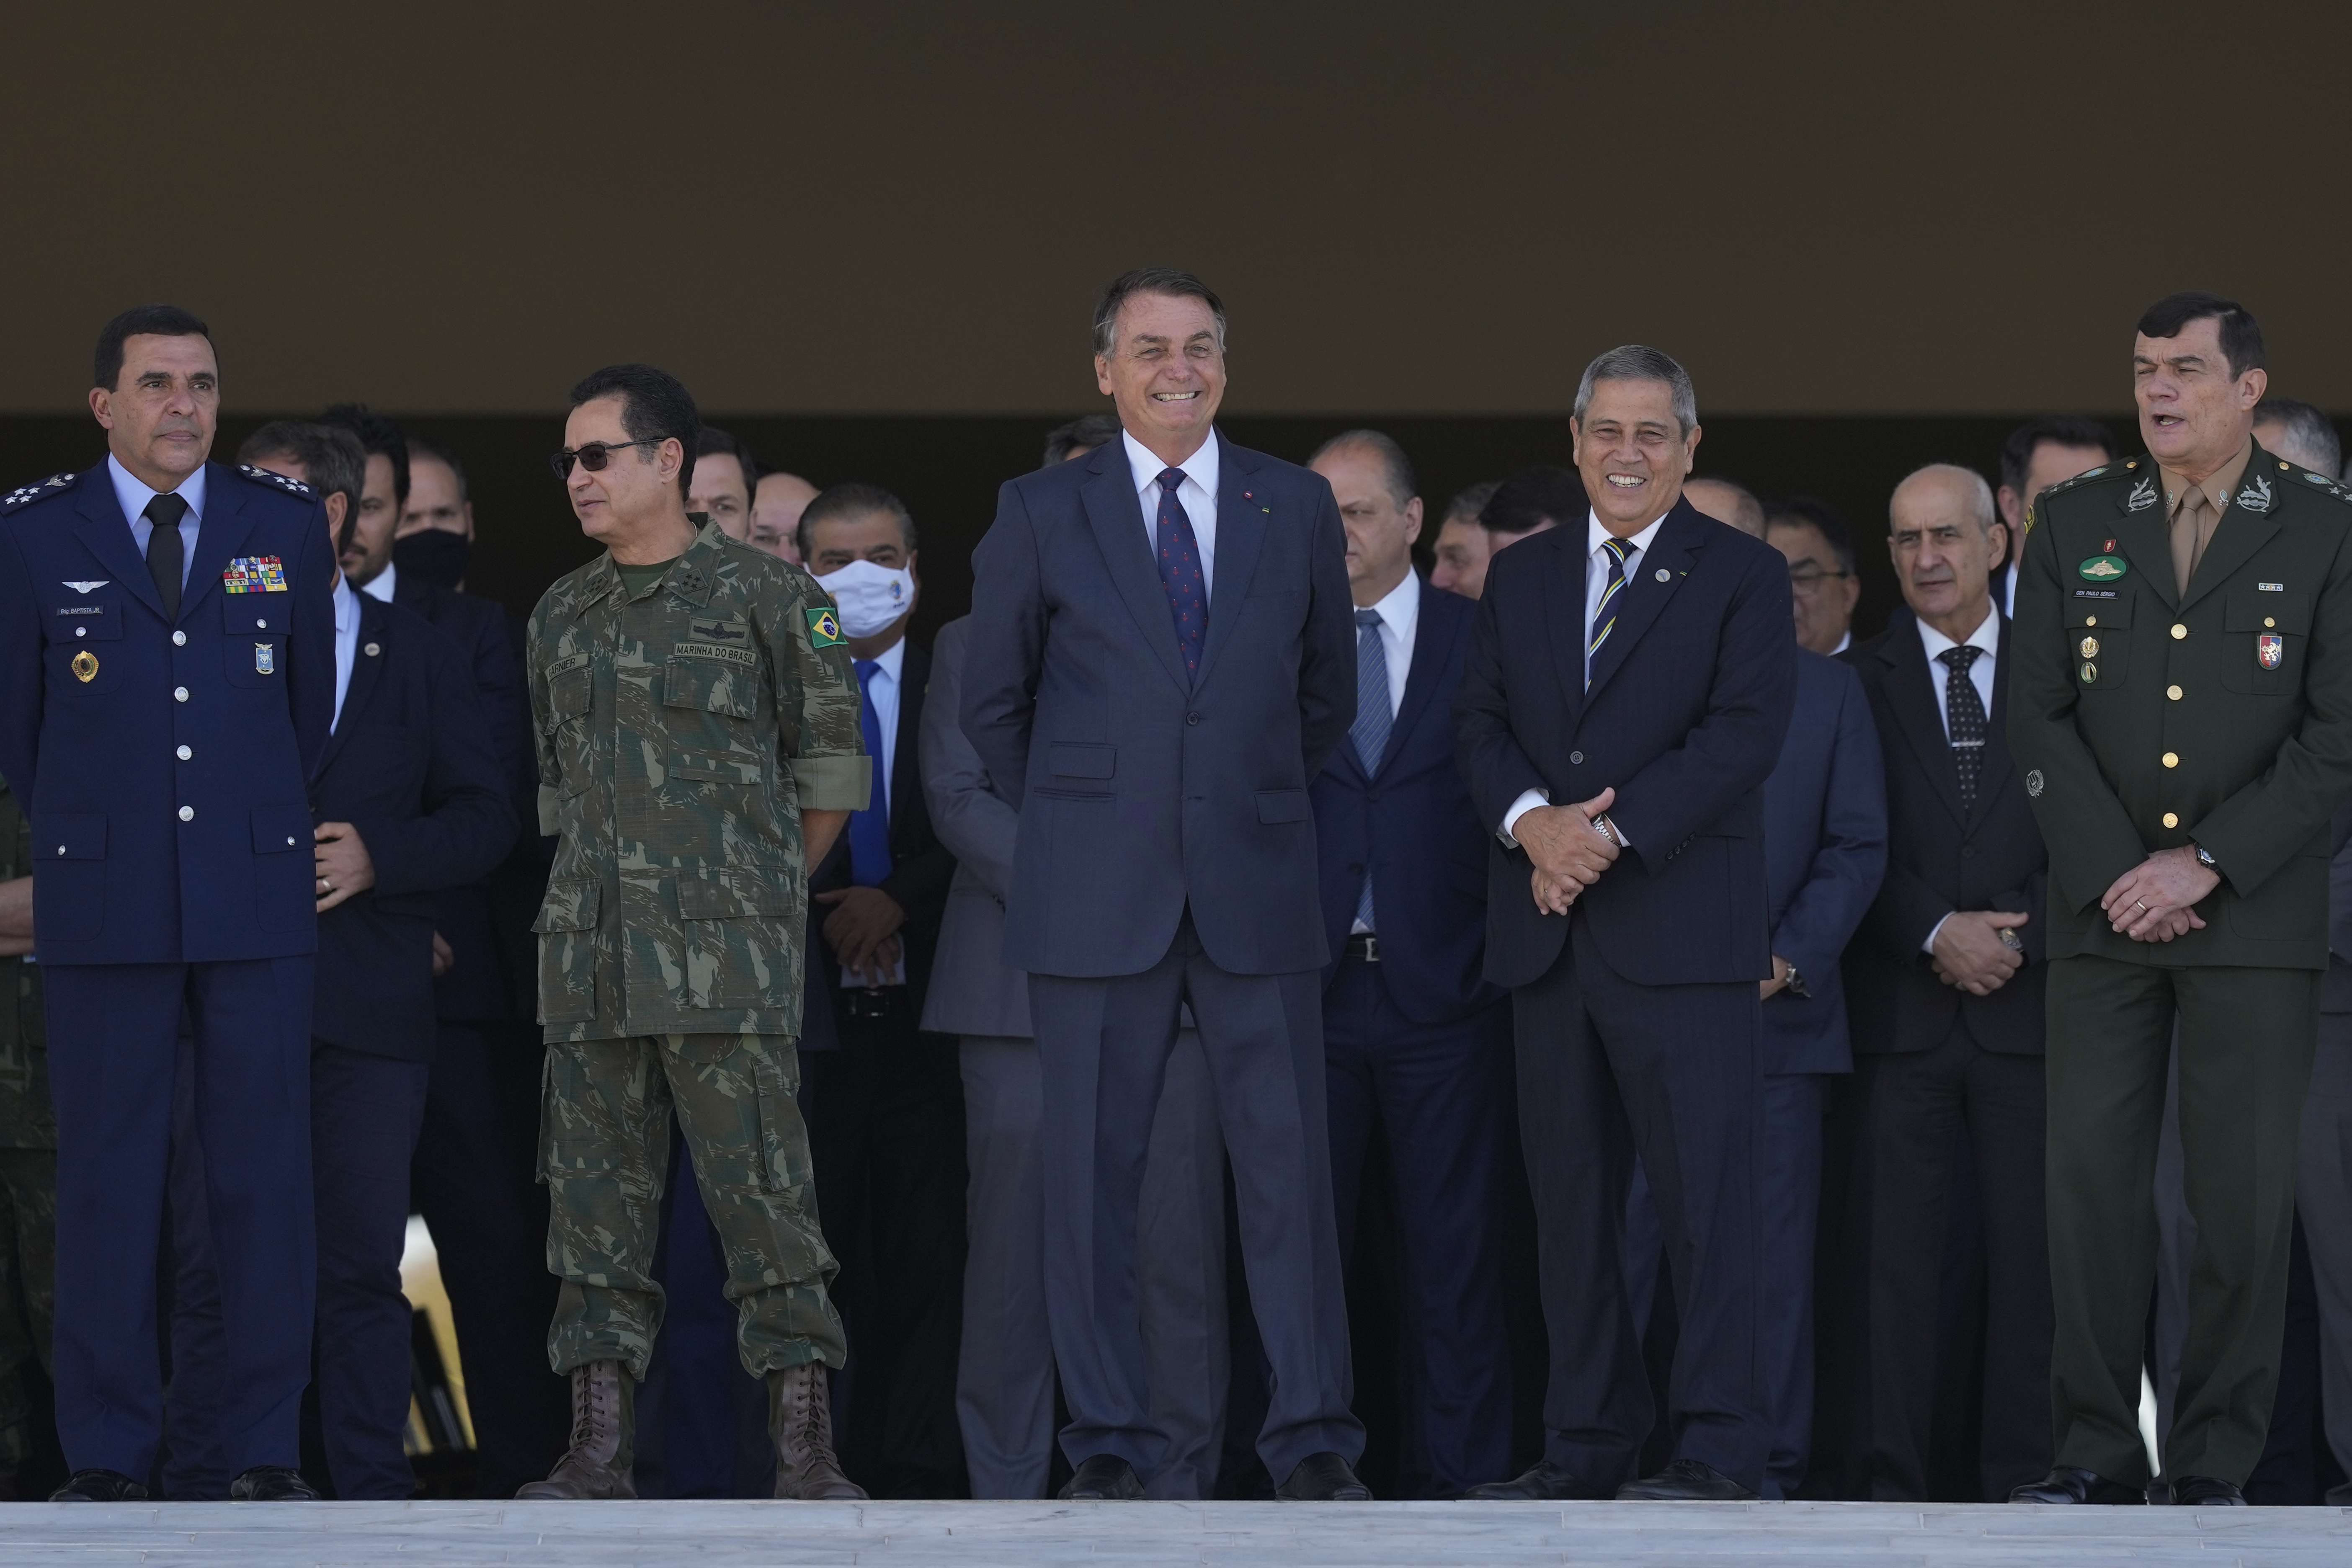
[1456,346,1797,1500]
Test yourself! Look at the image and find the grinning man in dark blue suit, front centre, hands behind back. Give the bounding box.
[962,268,1369,1498]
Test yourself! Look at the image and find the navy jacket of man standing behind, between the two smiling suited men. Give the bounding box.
[1310,583,1503,1023]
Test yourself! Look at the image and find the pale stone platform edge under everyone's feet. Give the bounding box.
[0,1502,2352,1568]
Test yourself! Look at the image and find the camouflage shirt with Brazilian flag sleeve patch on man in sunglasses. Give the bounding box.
[524,522,873,1044]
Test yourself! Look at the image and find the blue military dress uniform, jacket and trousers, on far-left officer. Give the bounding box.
[0,461,334,1479]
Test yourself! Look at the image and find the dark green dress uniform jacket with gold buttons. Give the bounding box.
[2009,447,2352,969]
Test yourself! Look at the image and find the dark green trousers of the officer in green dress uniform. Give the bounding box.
[2049,957,2319,1486]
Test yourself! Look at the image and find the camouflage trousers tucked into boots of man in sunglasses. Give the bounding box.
[539,1034,844,1380]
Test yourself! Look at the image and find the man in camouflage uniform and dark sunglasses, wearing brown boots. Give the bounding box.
[518,364,870,1498]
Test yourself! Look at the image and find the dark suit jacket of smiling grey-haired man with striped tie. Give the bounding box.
[1456,498,1797,985]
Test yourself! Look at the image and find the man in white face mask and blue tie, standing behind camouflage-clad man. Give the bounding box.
[797,484,965,1498]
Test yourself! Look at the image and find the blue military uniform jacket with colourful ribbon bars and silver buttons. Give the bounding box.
[0,463,334,964]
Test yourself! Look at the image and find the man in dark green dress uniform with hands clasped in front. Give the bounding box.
[2009,294,2352,1504]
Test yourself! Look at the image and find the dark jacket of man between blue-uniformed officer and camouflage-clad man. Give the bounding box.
[310,593,515,1063]
